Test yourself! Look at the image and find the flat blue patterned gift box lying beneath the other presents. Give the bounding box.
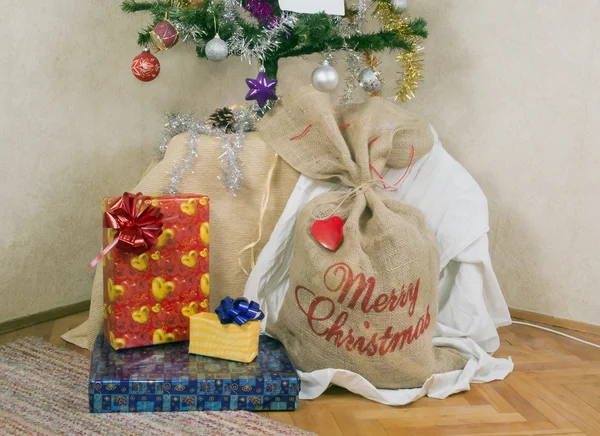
[89,336,300,413]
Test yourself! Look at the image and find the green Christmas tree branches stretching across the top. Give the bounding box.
[121,0,427,95]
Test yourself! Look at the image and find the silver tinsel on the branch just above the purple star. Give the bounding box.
[227,12,298,63]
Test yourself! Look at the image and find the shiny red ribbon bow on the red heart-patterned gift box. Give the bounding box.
[88,192,163,268]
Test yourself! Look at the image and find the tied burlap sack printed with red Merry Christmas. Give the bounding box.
[259,89,465,389]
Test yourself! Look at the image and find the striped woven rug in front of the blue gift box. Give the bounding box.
[0,338,313,436]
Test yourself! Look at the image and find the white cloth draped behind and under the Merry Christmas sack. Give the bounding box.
[244,127,514,405]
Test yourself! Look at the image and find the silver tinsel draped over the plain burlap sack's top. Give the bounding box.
[157,104,258,195]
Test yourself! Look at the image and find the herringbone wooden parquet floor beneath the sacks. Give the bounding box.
[0,313,600,436]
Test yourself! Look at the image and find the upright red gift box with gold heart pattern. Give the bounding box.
[102,194,210,349]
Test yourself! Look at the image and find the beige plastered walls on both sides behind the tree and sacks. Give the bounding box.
[0,0,600,324]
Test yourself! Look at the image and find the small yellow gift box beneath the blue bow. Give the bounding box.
[190,312,260,363]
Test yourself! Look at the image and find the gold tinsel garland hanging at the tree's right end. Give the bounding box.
[373,0,424,101]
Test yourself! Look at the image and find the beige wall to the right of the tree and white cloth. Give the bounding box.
[409,0,600,324]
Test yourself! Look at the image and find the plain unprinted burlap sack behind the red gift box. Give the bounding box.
[63,133,299,348]
